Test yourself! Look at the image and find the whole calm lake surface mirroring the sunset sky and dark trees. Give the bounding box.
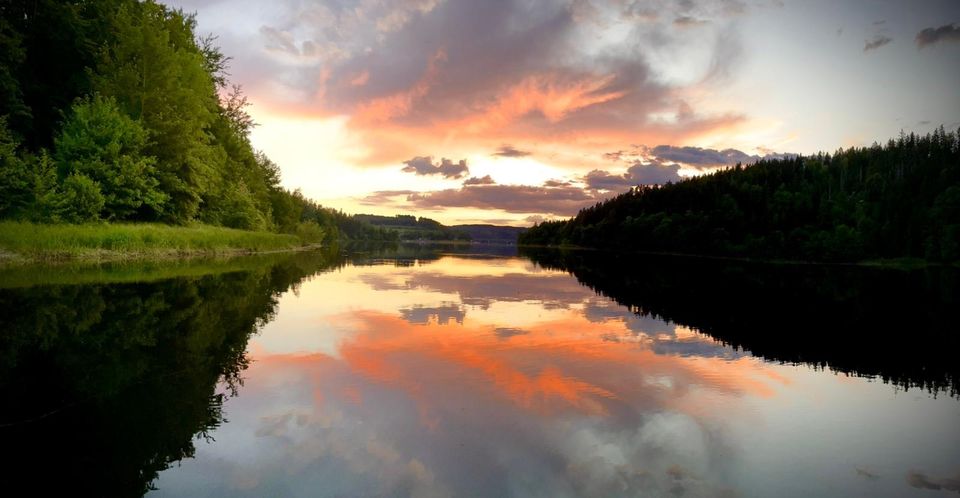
[0,246,960,497]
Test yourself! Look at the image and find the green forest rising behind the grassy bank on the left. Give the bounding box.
[0,0,392,245]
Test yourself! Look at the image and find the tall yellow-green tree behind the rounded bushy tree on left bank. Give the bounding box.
[95,0,219,223]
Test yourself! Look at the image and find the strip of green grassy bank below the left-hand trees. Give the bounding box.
[0,221,304,263]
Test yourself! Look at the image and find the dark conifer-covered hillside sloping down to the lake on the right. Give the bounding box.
[520,127,960,261]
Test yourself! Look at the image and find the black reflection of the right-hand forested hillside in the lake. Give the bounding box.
[525,249,960,396]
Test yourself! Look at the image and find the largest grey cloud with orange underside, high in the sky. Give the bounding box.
[221,0,746,166]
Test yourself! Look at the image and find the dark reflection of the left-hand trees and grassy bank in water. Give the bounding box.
[0,251,344,496]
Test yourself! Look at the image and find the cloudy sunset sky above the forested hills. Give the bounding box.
[167,0,960,226]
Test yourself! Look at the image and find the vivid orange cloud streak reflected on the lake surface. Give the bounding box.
[304,311,783,420]
